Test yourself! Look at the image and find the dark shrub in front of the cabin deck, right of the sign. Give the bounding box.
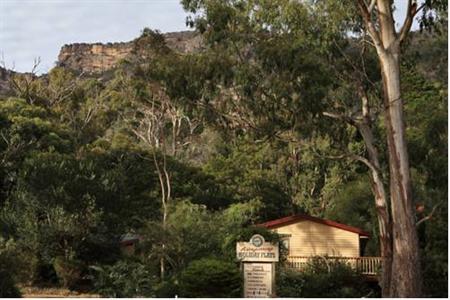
[277,257,378,298]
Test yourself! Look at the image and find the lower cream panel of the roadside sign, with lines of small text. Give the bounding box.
[244,263,275,298]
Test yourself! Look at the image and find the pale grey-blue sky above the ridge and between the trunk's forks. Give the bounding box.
[0,0,418,73]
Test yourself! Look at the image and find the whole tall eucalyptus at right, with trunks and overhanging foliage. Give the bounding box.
[182,0,447,297]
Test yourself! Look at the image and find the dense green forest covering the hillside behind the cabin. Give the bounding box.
[0,2,448,297]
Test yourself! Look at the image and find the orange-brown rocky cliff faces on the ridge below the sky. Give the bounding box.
[58,31,201,73]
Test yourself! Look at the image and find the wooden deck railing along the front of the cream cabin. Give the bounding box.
[286,256,381,275]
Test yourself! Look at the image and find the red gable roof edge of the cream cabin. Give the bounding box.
[257,214,370,237]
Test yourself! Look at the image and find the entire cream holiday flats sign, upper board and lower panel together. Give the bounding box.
[236,234,279,298]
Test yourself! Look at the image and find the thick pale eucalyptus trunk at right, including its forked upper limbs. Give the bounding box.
[356,0,422,297]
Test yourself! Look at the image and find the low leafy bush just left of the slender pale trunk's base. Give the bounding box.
[93,260,156,298]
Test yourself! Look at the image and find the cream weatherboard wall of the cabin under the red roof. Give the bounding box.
[272,220,360,257]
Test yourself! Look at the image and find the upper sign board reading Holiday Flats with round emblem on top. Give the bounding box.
[236,234,280,262]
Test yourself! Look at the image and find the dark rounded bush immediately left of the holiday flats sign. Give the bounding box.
[180,258,242,298]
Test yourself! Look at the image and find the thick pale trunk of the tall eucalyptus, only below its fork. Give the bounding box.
[379,50,422,297]
